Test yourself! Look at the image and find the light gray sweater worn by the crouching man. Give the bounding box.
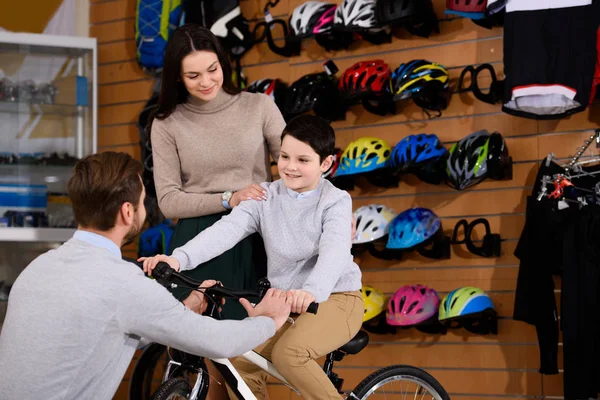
[0,239,275,400]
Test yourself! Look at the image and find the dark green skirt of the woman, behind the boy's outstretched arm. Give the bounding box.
[169,212,267,319]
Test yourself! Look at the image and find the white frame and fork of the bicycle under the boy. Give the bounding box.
[163,350,300,400]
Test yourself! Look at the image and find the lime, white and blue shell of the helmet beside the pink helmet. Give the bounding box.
[439,286,494,321]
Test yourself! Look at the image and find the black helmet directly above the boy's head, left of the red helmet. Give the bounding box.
[284,72,345,121]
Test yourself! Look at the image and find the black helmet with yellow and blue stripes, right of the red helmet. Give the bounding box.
[389,60,450,111]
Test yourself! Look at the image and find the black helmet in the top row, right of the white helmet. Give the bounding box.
[375,0,440,37]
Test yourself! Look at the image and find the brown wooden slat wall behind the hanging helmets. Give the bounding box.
[90,0,600,400]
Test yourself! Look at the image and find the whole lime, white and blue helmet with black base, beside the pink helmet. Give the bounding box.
[439,286,498,334]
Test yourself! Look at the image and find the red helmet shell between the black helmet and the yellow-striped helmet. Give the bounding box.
[339,60,392,99]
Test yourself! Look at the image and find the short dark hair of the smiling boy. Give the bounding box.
[281,115,335,162]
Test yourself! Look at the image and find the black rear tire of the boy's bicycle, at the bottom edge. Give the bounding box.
[348,364,450,400]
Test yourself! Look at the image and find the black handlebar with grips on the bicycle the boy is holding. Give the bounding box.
[152,262,319,314]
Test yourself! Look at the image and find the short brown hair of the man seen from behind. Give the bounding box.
[67,151,144,232]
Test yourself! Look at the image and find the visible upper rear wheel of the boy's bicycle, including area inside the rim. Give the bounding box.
[348,365,450,400]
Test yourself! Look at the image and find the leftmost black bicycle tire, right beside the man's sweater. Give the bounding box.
[129,343,167,400]
